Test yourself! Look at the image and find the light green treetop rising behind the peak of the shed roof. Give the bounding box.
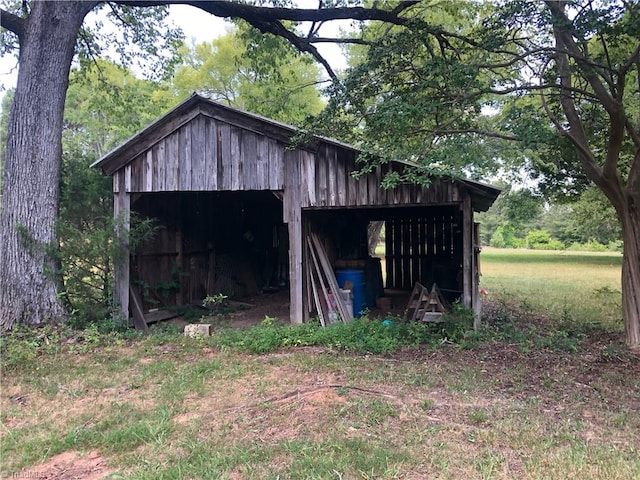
[173,22,323,124]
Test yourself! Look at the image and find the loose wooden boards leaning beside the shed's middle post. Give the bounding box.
[307,233,353,327]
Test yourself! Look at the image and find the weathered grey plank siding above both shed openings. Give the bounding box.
[114,114,462,208]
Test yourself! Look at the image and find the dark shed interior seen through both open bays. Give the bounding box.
[131,191,462,322]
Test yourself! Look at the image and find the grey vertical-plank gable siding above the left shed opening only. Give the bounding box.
[114,115,286,192]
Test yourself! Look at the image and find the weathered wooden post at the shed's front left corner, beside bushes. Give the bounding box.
[113,170,131,321]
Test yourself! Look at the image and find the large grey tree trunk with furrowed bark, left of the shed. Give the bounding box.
[0,1,94,329]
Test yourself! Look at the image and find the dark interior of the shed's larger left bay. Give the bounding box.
[131,191,289,309]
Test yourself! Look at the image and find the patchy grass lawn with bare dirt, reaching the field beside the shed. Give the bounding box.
[0,250,640,480]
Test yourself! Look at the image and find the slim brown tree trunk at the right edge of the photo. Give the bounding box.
[619,202,640,349]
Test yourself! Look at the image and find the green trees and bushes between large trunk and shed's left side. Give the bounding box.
[55,60,169,330]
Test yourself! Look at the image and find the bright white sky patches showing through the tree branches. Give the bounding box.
[0,0,350,98]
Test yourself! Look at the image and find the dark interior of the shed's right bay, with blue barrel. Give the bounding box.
[305,205,463,314]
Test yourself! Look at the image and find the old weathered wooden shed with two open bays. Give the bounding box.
[94,94,500,323]
